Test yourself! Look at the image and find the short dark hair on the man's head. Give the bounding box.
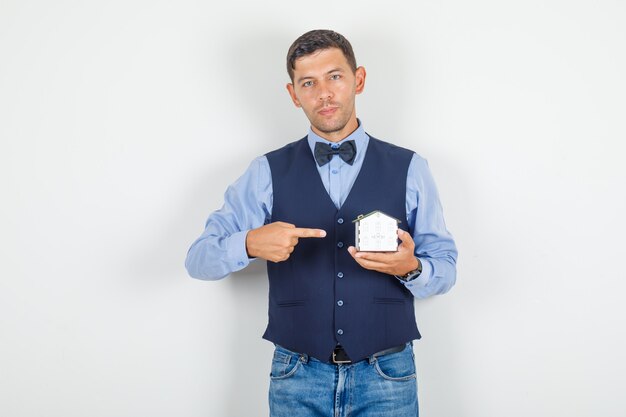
[287,29,356,82]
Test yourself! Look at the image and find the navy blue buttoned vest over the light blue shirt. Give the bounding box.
[263,137,420,362]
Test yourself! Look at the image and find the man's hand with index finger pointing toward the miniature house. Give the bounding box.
[246,222,326,262]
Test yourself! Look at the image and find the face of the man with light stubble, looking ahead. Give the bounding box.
[287,48,365,142]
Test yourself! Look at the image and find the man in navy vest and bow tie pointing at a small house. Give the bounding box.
[186,30,457,417]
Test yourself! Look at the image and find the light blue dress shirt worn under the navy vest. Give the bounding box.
[185,121,457,298]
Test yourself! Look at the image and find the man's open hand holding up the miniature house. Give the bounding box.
[348,229,419,276]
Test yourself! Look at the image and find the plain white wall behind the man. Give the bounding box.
[0,0,626,417]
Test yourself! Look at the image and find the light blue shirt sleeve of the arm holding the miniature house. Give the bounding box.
[401,154,458,298]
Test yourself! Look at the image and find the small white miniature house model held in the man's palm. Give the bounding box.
[353,210,400,252]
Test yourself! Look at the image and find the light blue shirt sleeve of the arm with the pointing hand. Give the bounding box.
[185,156,273,280]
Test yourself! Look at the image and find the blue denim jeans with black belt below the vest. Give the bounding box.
[269,343,419,417]
